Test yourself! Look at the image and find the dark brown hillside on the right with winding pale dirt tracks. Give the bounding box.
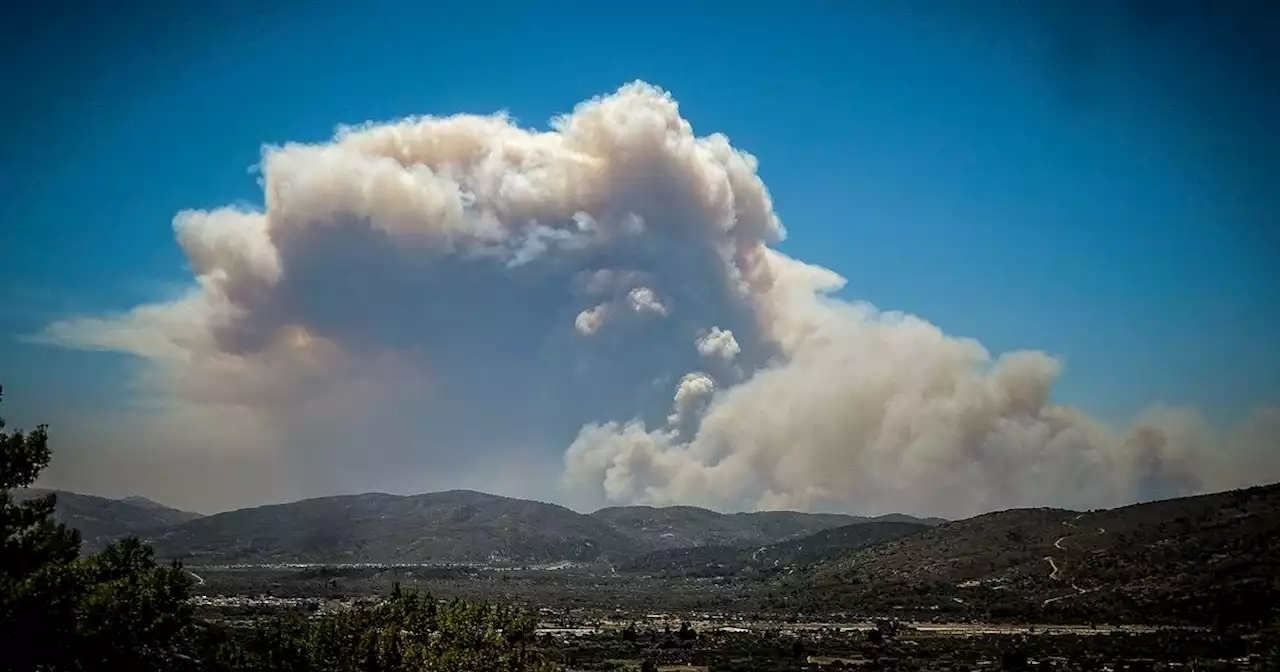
[776,485,1280,622]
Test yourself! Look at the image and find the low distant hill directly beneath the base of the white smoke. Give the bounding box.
[591,507,942,549]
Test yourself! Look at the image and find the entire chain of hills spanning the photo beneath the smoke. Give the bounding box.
[15,484,1280,625]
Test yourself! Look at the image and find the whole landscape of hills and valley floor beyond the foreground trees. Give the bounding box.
[19,485,1280,672]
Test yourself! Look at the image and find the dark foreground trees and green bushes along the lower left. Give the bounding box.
[0,386,554,672]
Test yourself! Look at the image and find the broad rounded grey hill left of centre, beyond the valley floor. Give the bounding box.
[151,490,636,563]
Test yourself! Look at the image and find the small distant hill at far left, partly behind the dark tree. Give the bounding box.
[13,488,200,553]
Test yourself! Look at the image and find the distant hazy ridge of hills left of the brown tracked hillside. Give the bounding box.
[24,489,936,564]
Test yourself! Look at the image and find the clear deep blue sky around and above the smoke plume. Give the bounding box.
[0,0,1280,424]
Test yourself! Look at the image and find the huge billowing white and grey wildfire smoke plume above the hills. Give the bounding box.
[37,83,1280,516]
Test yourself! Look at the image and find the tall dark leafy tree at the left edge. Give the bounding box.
[0,390,192,671]
